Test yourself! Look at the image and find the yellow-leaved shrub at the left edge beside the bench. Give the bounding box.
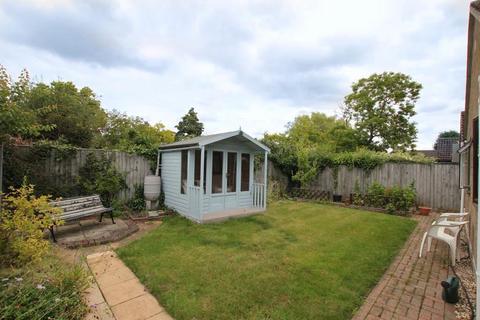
[0,182,61,264]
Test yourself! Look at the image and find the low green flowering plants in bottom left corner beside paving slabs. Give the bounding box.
[0,257,88,320]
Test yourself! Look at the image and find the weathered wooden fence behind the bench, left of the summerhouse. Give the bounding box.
[5,146,152,200]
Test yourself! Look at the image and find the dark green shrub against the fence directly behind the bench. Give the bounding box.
[78,153,127,207]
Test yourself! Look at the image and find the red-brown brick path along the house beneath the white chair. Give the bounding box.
[353,212,455,320]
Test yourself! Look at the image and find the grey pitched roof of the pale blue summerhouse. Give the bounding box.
[159,130,270,152]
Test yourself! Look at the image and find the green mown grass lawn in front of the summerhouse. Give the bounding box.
[118,201,416,319]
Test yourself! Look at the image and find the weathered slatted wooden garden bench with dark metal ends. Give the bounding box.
[49,194,115,242]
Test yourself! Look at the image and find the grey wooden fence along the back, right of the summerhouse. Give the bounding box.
[309,163,460,210]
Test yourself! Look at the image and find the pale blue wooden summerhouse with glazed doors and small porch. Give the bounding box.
[158,130,270,222]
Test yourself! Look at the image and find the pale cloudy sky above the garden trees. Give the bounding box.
[0,0,469,149]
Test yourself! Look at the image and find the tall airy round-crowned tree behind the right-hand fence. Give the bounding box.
[343,72,422,151]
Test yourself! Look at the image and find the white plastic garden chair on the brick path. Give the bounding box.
[418,219,468,266]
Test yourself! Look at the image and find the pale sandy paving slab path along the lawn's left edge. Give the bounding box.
[87,251,173,320]
